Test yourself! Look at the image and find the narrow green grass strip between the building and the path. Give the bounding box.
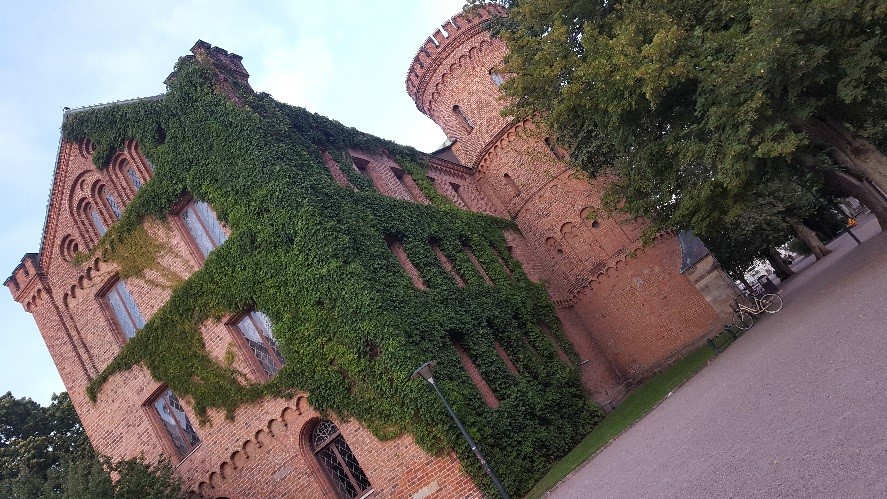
[526,344,729,499]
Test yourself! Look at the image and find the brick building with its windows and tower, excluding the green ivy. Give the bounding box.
[6,6,733,497]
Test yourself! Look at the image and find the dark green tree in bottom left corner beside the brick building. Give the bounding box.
[0,392,184,499]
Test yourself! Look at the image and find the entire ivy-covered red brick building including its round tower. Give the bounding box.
[6,6,733,498]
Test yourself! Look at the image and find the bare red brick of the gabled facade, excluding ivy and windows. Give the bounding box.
[7,144,480,498]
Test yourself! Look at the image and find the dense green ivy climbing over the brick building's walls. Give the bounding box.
[63,55,600,494]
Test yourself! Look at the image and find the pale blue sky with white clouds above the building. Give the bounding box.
[0,0,464,405]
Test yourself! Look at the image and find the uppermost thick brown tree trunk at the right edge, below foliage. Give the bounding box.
[797,114,887,192]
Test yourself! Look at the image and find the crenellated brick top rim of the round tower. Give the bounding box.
[406,4,507,115]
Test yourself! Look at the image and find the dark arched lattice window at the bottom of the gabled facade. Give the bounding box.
[310,420,372,499]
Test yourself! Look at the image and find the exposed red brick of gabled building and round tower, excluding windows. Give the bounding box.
[7,7,736,497]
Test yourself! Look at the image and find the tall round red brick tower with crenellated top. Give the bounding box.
[406,5,724,404]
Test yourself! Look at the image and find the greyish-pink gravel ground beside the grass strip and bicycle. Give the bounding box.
[549,215,887,498]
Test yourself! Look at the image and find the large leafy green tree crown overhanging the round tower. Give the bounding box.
[497,0,887,234]
